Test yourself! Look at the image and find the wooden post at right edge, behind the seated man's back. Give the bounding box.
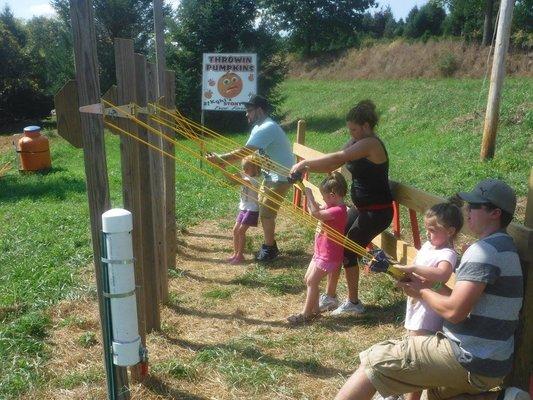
[508,169,533,391]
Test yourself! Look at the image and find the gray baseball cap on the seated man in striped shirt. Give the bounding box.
[457,179,516,215]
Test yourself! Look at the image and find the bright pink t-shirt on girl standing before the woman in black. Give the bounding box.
[313,204,348,266]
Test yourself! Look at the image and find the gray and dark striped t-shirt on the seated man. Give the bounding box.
[444,231,524,377]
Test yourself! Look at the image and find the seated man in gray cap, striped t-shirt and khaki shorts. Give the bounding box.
[336,179,529,400]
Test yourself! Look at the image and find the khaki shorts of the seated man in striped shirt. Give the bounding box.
[360,333,503,400]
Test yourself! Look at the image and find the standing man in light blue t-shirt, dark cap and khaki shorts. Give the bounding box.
[207,95,296,261]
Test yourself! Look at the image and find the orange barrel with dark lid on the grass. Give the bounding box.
[18,126,52,171]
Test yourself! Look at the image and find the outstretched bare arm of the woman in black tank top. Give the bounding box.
[291,138,377,173]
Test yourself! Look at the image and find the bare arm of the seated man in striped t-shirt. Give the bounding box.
[397,276,487,324]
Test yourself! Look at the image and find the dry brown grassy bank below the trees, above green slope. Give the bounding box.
[289,40,533,80]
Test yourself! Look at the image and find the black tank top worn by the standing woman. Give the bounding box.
[345,137,392,207]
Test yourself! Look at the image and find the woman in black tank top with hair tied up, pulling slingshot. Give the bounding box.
[291,100,393,314]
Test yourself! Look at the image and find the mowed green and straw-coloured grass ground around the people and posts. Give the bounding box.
[0,78,533,399]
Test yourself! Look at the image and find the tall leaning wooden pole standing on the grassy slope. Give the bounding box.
[481,0,514,160]
